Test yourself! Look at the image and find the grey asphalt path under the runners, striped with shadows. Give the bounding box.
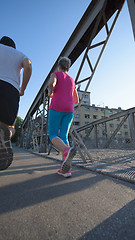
[0,148,135,240]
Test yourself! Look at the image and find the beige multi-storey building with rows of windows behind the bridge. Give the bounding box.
[74,89,130,148]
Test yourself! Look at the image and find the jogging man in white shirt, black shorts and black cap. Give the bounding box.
[0,36,32,170]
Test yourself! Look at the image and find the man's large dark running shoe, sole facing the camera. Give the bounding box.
[0,124,13,170]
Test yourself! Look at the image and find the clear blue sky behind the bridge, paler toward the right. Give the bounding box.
[0,0,135,119]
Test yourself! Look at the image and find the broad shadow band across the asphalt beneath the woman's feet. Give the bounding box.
[0,169,104,214]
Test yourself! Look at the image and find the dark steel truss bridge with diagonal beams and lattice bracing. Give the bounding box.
[21,0,135,161]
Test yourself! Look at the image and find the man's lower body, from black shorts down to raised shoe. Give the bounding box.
[0,80,20,170]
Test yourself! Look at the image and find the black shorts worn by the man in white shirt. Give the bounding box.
[0,80,20,126]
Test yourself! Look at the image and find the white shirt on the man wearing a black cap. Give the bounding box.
[0,44,27,91]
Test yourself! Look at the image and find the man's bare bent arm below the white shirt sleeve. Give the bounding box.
[20,58,32,96]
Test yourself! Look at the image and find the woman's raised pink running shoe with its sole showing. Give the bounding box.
[61,147,76,174]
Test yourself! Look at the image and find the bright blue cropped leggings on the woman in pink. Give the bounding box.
[48,109,74,144]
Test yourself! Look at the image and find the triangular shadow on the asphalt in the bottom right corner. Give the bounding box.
[78,200,135,240]
